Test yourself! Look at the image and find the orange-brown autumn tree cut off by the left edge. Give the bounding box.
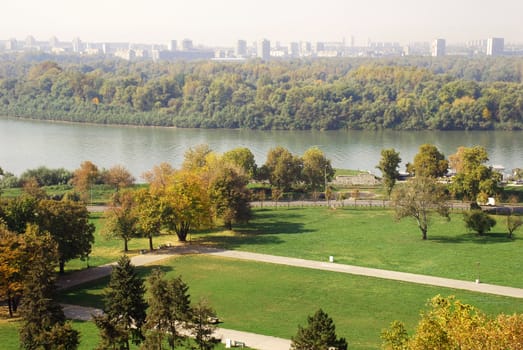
[0,223,26,317]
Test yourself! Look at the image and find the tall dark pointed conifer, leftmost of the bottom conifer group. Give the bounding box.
[95,255,147,350]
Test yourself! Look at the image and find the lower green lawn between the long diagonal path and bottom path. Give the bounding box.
[58,255,523,349]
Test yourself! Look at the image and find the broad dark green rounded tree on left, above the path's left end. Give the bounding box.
[36,200,95,274]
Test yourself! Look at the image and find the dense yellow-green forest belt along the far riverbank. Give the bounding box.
[0,54,523,130]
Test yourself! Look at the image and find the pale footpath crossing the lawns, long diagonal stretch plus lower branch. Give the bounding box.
[57,245,523,350]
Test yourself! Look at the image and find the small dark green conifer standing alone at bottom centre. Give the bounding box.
[291,309,347,350]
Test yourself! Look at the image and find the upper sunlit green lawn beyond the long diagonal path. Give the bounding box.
[194,207,523,288]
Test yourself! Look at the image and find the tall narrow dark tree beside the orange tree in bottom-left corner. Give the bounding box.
[20,226,79,350]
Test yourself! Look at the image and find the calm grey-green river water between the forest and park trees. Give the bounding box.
[0,118,523,178]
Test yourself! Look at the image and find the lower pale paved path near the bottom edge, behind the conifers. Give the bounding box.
[61,304,291,350]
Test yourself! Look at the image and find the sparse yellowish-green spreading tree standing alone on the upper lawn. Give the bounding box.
[392,176,450,240]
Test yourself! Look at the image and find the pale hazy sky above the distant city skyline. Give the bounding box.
[0,0,523,46]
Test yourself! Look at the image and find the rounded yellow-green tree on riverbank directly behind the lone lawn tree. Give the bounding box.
[412,144,449,177]
